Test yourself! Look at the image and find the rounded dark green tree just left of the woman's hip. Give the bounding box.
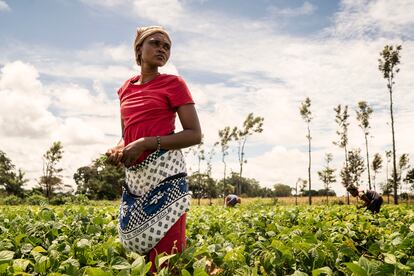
[73,155,125,200]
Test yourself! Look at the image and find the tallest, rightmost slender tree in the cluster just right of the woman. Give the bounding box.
[233,113,264,195]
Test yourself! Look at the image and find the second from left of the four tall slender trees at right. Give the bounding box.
[333,105,349,204]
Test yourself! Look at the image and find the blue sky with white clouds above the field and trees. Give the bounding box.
[0,0,414,194]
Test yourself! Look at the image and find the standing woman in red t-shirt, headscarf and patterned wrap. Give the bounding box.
[107,26,201,264]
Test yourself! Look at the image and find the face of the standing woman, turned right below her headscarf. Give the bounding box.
[139,33,171,66]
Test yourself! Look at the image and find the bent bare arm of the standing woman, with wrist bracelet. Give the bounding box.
[121,104,201,167]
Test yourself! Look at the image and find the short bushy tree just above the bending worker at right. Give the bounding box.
[341,149,365,188]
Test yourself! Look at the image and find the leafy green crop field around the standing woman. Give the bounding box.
[0,201,414,276]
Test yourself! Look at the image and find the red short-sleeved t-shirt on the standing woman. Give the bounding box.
[118,74,194,162]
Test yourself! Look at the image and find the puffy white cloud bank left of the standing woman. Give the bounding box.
[0,61,119,189]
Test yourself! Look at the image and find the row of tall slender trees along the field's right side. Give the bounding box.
[299,45,414,204]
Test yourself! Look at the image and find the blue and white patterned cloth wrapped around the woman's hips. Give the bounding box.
[118,150,190,255]
